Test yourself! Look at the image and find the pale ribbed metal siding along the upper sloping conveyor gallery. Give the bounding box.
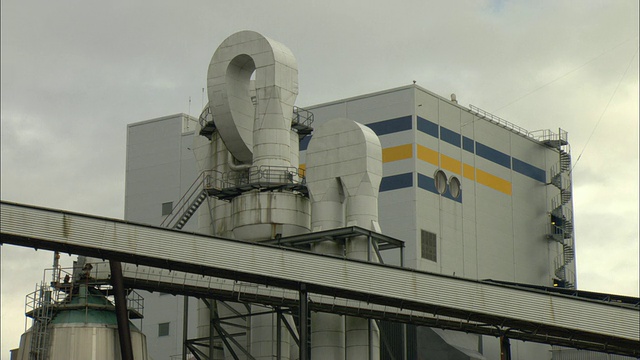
[1,203,640,341]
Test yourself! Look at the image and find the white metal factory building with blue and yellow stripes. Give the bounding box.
[125,85,575,359]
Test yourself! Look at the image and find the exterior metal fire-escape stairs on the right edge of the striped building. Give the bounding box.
[539,129,576,289]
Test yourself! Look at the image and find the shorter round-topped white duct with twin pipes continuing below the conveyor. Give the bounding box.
[307,119,382,360]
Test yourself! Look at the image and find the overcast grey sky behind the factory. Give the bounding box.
[0,0,639,354]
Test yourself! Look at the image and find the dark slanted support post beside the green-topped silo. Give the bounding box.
[109,260,133,360]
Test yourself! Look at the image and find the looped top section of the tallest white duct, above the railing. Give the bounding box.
[207,31,298,167]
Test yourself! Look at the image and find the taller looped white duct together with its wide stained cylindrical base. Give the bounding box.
[204,31,310,359]
